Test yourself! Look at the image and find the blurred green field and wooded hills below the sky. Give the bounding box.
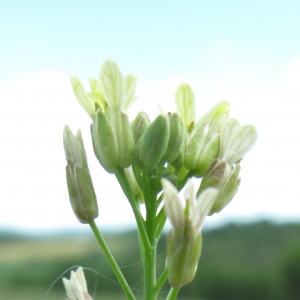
[0,222,300,300]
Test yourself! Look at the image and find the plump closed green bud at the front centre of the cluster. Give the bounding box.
[139,115,170,167]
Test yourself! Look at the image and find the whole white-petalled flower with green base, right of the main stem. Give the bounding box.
[162,179,218,288]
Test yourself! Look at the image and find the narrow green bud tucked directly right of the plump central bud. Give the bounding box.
[164,113,185,163]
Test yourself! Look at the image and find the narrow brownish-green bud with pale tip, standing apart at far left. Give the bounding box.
[63,126,98,224]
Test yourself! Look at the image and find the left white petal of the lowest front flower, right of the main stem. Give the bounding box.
[161,179,184,230]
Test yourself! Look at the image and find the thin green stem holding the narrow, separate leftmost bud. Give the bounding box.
[89,220,135,300]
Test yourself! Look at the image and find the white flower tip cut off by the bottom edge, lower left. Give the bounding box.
[63,267,93,300]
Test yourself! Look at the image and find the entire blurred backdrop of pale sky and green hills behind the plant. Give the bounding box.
[0,0,300,300]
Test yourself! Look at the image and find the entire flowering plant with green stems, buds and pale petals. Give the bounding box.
[63,60,257,300]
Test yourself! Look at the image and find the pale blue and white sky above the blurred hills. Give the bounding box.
[0,0,300,231]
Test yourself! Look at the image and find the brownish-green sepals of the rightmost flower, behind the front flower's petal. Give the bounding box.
[198,160,241,215]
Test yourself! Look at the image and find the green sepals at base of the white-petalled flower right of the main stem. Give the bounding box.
[167,230,202,288]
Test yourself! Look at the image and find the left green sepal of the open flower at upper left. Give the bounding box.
[91,110,119,173]
